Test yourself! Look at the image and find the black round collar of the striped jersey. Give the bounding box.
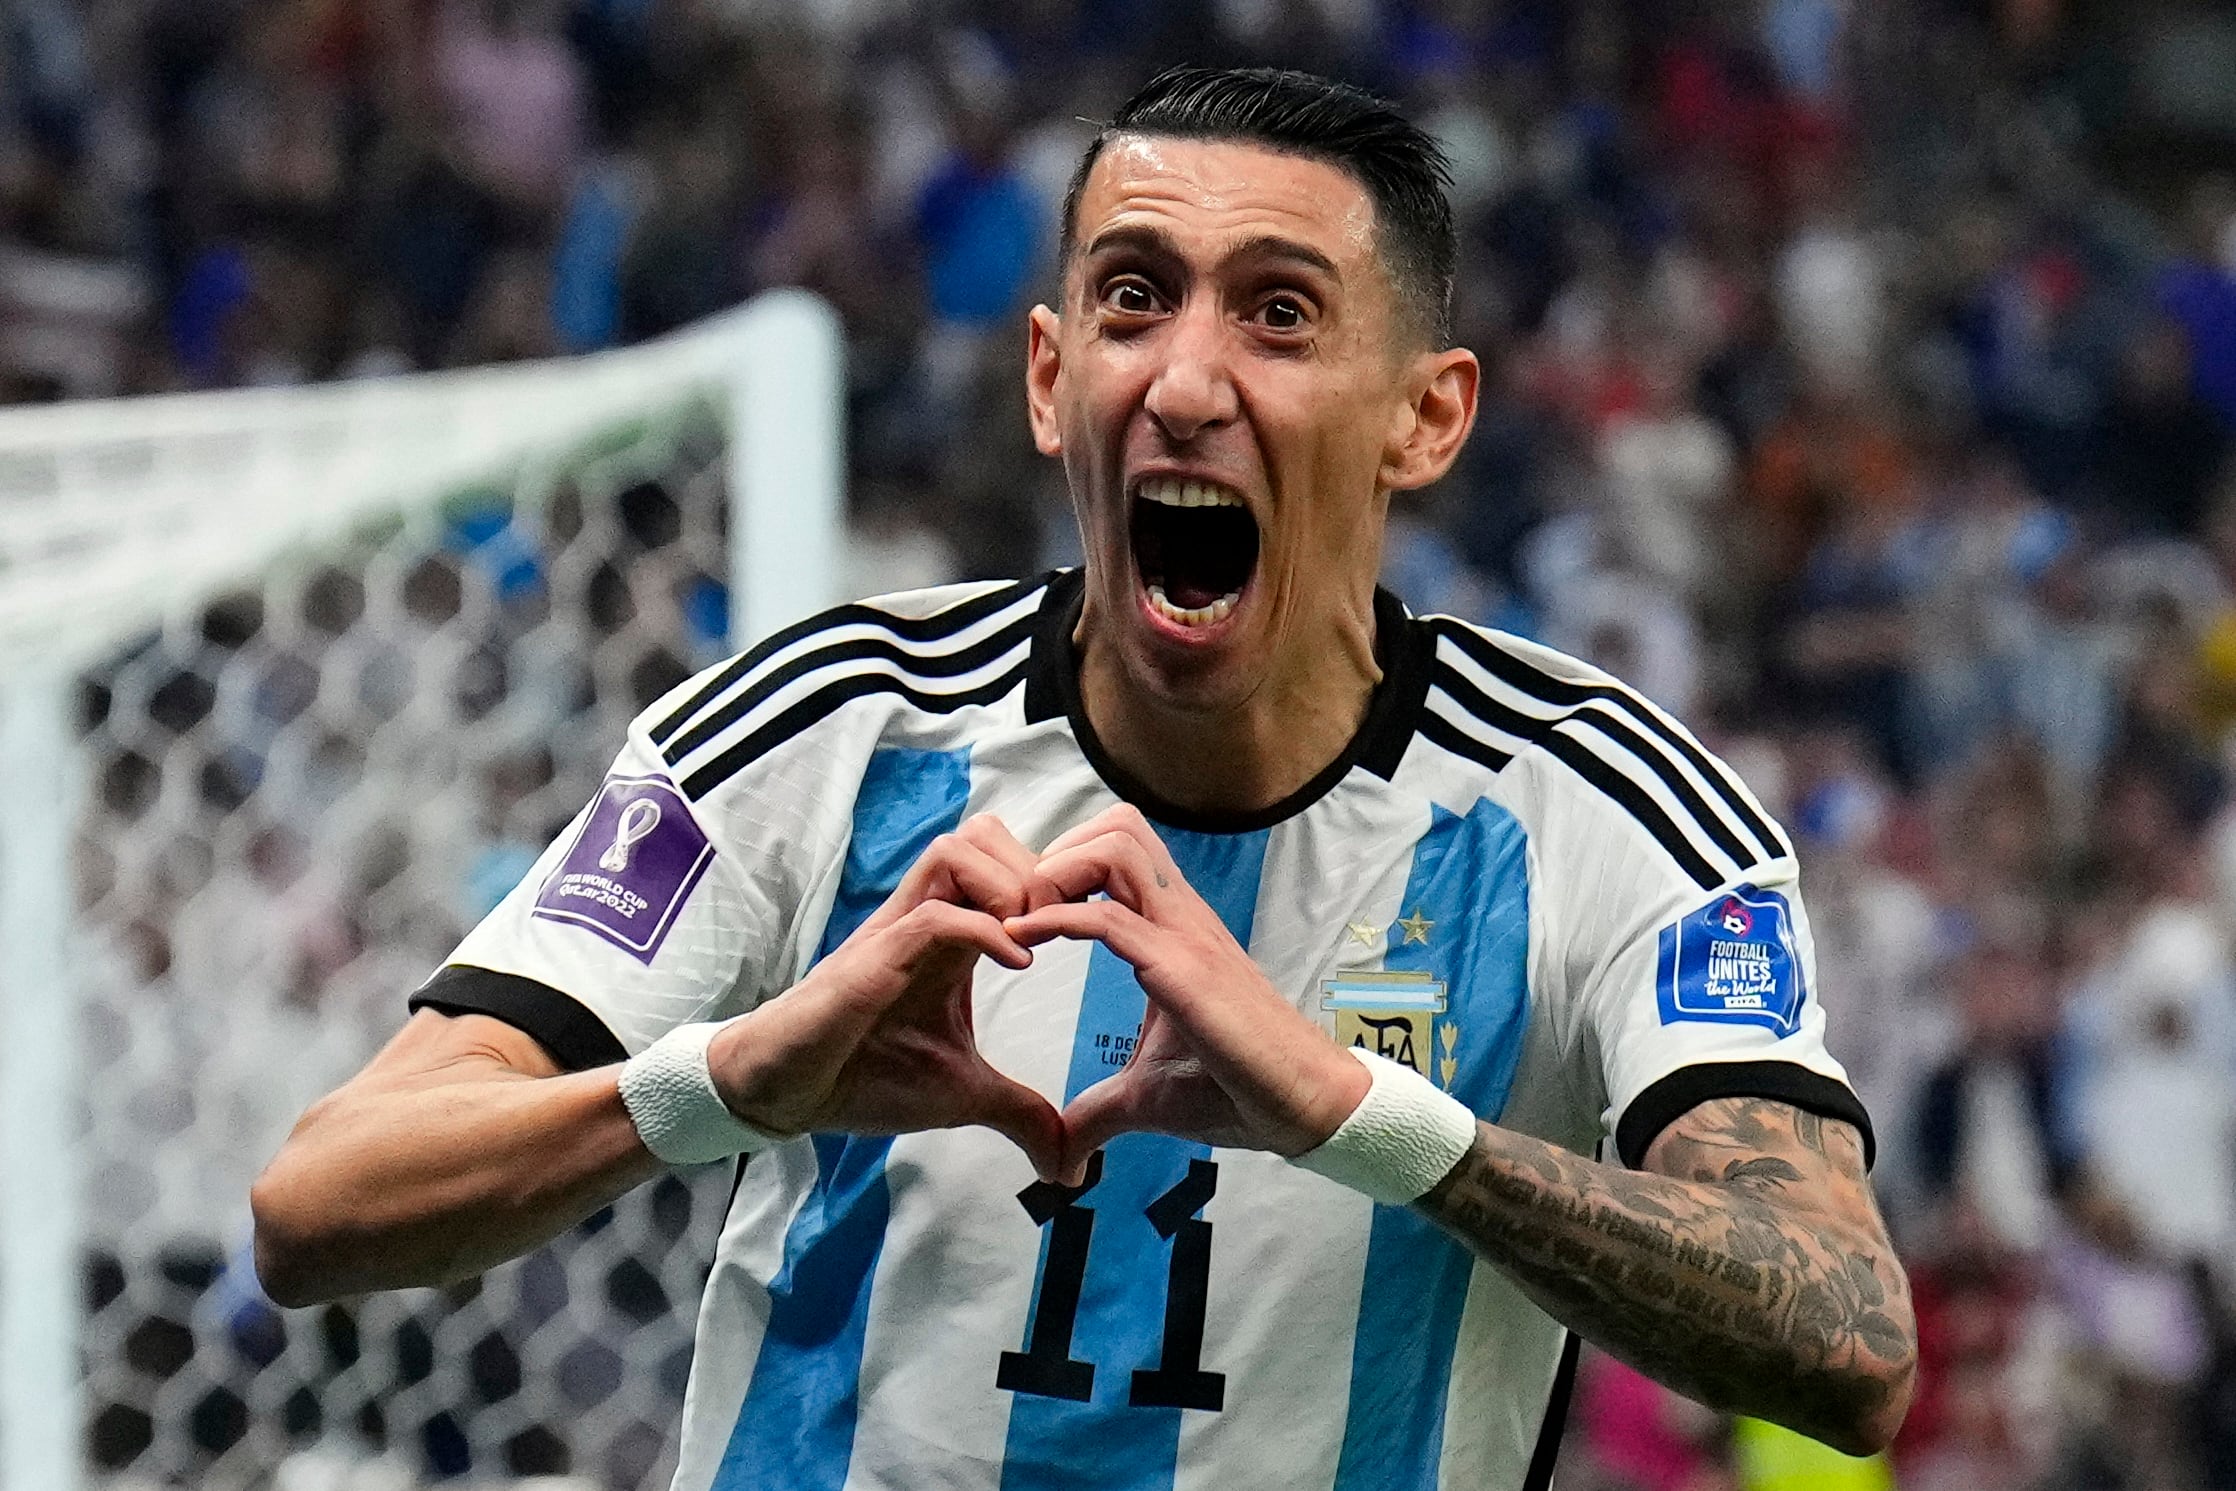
[1024,570,1436,834]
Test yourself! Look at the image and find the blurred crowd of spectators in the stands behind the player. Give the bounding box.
[21,0,2236,1491]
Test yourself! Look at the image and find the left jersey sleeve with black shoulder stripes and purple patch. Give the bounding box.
[411,579,1051,1069]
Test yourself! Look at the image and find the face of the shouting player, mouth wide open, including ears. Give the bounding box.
[1026,136,1474,713]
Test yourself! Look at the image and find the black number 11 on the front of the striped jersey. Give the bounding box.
[995,1151,1228,1413]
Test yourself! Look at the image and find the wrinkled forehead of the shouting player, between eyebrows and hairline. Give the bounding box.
[1073,134,1375,279]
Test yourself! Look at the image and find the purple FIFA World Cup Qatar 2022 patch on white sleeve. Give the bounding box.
[534,776,713,963]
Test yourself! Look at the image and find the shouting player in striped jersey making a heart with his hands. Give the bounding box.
[255,69,1916,1491]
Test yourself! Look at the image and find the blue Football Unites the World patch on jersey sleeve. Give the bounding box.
[1655,885,1809,1035]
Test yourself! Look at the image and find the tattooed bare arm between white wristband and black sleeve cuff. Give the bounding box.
[1418,1098,1918,1455]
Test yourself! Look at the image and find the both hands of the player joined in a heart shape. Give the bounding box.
[709,807,1368,1183]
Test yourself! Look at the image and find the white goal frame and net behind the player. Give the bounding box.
[0,295,841,1491]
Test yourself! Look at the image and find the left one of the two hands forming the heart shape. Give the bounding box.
[707,814,1064,1178]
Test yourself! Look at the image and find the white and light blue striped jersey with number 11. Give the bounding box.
[414,572,1869,1491]
